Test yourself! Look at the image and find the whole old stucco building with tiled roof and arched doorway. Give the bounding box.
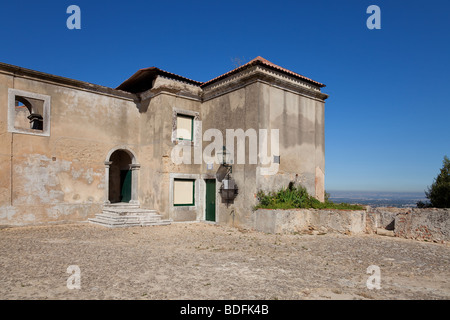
[0,57,328,225]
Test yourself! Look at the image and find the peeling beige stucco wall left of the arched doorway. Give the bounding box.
[0,72,139,225]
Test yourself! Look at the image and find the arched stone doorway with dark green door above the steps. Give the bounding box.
[105,147,140,204]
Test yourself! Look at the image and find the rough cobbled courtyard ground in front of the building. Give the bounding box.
[0,223,450,300]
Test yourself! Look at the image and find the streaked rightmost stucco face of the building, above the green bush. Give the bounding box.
[258,83,325,201]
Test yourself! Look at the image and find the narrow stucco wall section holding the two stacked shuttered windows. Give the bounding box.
[139,77,203,221]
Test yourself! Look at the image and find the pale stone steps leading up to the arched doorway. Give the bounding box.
[88,203,171,228]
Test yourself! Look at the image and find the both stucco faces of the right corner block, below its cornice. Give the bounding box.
[202,76,325,225]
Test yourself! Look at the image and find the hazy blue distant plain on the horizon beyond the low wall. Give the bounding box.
[327,190,428,208]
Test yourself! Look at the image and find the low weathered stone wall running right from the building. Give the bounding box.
[251,207,450,242]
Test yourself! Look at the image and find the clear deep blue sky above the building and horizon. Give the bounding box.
[0,0,450,192]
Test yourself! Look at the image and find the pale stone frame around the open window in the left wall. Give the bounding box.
[8,88,51,137]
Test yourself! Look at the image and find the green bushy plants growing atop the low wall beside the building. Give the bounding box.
[255,182,364,210]
